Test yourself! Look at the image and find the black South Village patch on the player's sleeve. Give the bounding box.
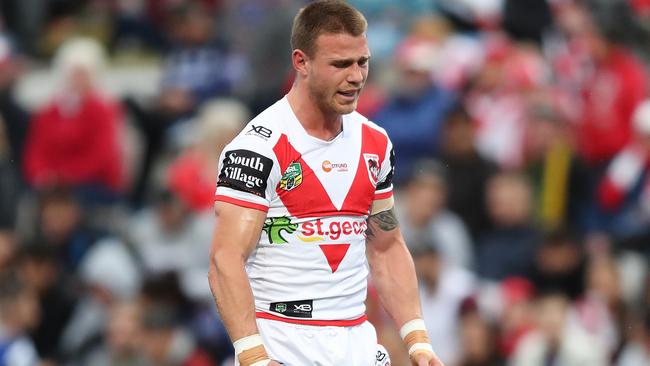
[217,150,273,197]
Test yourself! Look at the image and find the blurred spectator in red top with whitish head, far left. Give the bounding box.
[23,39,123,202]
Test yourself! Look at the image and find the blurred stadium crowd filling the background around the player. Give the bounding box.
[0,0,650,366]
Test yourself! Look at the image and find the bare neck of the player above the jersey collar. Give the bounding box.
[287,83,343,141]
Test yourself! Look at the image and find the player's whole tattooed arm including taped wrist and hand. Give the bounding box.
[366,197,443,366]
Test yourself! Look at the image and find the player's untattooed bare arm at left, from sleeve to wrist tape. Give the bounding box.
[208,202,266,341]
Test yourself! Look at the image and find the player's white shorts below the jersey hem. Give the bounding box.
[235,319,390,366]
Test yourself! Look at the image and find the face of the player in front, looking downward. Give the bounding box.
[306,33,370,114]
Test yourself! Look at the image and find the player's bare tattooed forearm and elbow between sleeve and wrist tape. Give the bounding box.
[366,203,422,328]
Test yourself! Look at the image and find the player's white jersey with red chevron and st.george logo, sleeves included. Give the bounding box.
[215,97,394,325]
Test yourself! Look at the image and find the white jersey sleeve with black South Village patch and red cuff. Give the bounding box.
[215,135,280,212]
